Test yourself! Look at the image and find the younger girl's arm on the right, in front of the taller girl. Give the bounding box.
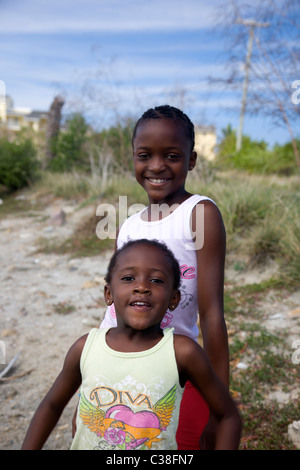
[174,335,242,450]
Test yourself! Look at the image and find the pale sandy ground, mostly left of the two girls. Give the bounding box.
[0,196,300,450]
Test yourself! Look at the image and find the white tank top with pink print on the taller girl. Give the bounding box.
[100,195,214,341]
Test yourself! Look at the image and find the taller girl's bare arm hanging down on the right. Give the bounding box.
[192,201,229,386]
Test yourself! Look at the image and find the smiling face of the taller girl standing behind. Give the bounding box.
[133,118,197,205]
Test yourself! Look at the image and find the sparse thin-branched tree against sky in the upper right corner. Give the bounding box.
[211,0,300,170]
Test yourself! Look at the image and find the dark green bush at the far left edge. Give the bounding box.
[0,138,39,190]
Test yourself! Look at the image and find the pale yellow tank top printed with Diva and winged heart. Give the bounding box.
[71,328,183,450]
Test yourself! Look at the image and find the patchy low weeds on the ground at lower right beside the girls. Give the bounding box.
[225,260,300,450]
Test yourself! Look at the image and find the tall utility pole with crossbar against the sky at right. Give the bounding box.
[236,18,270,152]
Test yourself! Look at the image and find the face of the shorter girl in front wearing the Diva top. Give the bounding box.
[105,244,180,331]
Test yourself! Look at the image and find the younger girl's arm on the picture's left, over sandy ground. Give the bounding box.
[22,335,87,450]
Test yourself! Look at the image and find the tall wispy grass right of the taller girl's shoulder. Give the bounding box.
[189,172,300,288]
